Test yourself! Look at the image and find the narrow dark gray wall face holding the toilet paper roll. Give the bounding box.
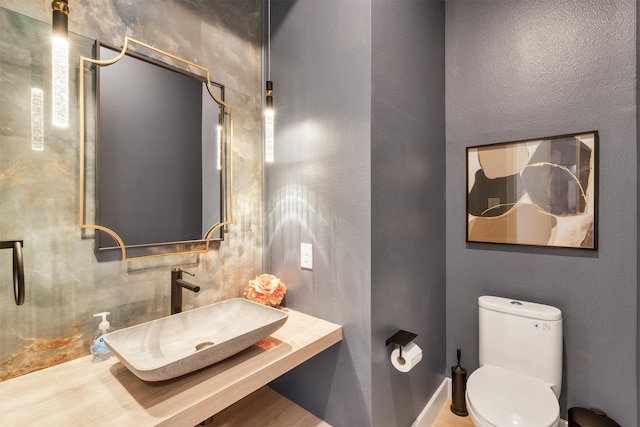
[371,1,446,427]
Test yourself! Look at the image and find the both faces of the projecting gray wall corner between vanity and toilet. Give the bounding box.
[265,0,445,426]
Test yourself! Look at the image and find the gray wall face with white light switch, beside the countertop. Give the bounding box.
[264,0,372,426]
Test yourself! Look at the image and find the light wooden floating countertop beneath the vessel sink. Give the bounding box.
[0,309,342,426]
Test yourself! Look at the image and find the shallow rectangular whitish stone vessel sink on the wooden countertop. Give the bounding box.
[104,298,289,381]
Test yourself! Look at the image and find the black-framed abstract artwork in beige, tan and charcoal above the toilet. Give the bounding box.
[467,131,598,250]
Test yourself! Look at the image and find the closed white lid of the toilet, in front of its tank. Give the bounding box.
[467,365,560,427]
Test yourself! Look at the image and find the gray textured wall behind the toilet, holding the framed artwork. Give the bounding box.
[446,0,638,426]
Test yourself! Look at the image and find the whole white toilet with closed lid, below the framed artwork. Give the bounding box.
[466,296,562,427]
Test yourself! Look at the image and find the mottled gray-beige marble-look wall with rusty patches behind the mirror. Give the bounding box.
[0,0,262,380]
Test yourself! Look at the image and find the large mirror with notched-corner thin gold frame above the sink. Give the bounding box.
[78,37,234,261]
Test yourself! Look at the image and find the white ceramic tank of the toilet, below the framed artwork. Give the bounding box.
[478,296,562,397]
